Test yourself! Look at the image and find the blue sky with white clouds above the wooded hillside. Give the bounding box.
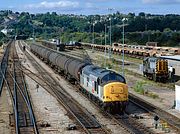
[0,0,180,15]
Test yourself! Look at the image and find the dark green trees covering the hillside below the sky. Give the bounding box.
[0,11,180,46]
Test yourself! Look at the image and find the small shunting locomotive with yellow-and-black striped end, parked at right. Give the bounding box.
[143,57,169,82]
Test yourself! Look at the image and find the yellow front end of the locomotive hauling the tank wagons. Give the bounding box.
[103,82,128,113]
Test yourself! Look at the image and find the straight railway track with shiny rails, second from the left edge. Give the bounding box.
[4,41,38,134]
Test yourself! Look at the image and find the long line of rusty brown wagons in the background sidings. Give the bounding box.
[82,43,180,59]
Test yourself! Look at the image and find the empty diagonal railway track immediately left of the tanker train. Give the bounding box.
[19,40,109,134]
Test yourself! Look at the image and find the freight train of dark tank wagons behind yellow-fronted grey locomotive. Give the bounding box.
[30,44,128,113]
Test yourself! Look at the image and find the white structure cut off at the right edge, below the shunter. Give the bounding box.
[175,81,180,111]
